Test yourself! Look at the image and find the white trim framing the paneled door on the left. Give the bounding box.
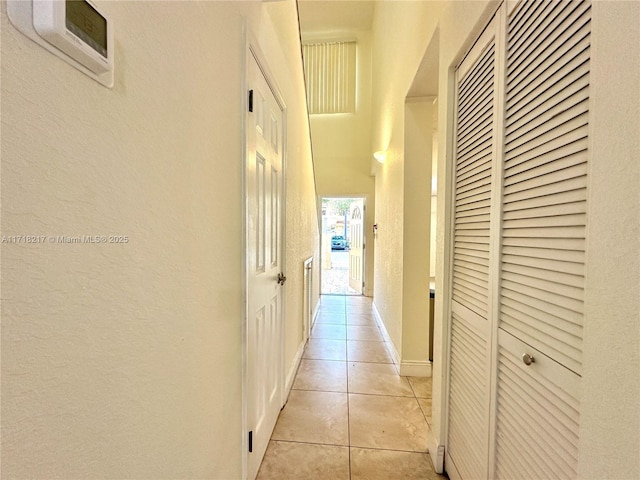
[240,31,288,479]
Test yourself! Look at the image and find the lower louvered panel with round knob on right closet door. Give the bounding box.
[496,332,580,479]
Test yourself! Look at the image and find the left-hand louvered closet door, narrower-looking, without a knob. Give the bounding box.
[445,12,497,479]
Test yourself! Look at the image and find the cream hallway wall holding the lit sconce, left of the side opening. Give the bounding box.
[371,2,440,357]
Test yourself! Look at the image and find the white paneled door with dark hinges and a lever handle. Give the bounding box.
[246,48,284,479]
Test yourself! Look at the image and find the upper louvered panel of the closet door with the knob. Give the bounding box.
[500,2,591,374]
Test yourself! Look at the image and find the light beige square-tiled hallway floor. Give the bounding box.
[258,295,446,480]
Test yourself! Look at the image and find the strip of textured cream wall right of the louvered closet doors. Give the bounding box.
[579,2,640,480]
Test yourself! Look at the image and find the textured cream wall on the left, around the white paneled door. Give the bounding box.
[1,2,318,479]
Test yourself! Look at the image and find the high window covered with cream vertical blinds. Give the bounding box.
[302,41,356,114]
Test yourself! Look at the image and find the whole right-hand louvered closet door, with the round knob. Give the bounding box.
[493,1,591,479]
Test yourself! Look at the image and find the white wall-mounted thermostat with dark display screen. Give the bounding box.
[7,0,114,87]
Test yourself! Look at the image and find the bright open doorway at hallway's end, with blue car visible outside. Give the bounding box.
[320,197,365,295]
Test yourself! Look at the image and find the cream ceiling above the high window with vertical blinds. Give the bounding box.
[298,0,374,34]
